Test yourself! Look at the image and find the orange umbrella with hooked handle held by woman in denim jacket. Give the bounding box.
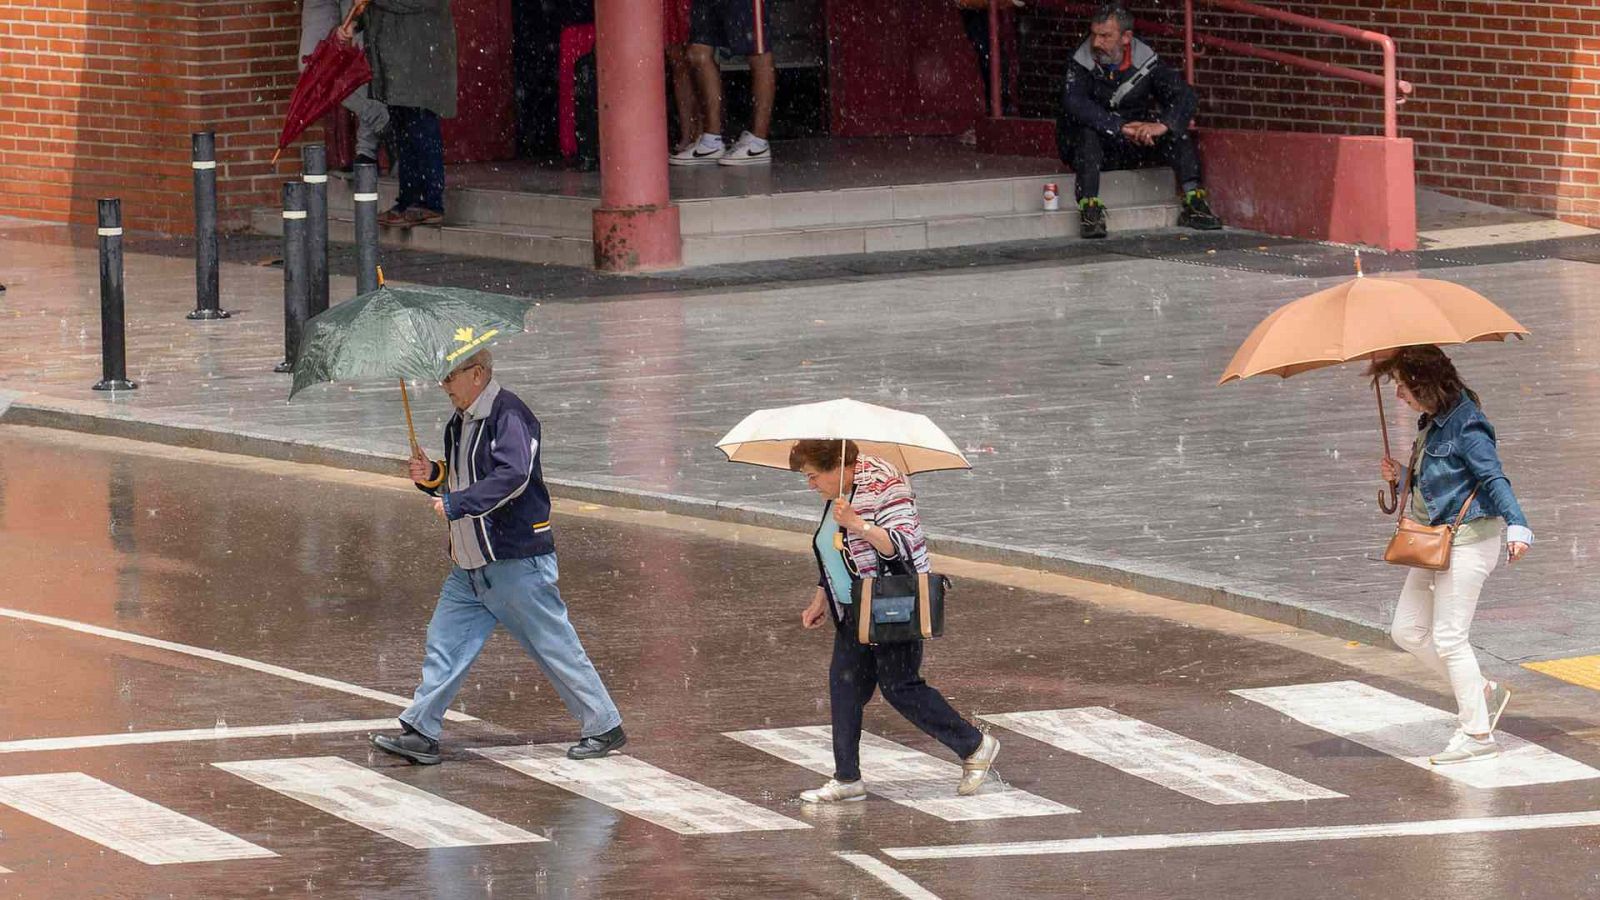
[1218,259,1530,512]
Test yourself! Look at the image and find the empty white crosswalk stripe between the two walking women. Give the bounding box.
[979,706,1344,804]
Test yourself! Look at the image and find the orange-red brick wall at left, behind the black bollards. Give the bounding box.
[0,0,299,234]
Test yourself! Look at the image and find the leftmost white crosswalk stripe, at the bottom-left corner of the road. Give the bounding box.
[0,772,277,865]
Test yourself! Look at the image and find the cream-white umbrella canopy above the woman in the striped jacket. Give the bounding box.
[717,397,971,476]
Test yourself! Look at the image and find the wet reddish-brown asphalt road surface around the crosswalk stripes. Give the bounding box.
[0,428,1600,900]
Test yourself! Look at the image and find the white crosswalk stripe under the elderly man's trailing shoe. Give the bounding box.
[472,743,810,834]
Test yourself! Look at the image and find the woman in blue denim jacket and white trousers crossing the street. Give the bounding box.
[1371,346,1533,765]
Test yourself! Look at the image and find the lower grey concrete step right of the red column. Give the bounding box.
[683,202,1178,266]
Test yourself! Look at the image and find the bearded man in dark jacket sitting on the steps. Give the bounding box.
[1056,3,1222,237]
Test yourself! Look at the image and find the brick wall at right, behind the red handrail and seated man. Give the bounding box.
[1021,0,1600,227]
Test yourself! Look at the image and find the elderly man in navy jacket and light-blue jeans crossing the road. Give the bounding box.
[373,351,627,765]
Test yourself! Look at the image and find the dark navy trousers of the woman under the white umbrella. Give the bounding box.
[827,628,984,781]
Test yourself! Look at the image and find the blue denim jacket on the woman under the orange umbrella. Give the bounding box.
[1400,394,1533,544]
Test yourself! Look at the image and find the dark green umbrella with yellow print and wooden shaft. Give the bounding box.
[290,279,530,447]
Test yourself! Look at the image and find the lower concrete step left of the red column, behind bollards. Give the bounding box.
[250,210,595,266]
